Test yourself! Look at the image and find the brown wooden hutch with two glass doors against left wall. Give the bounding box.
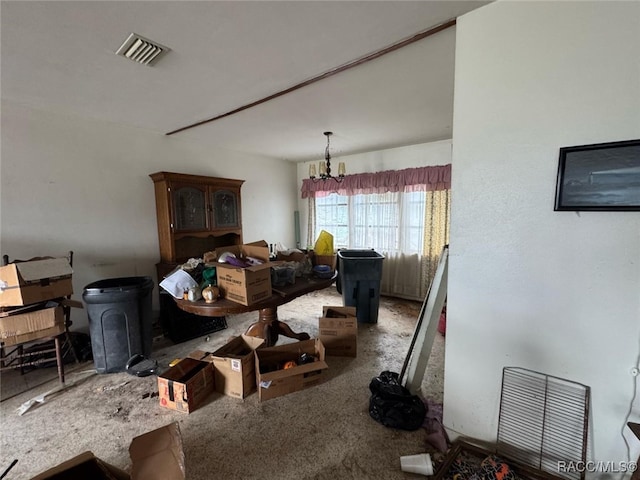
[150,172,244,270]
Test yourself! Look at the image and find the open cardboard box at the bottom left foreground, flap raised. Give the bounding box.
[32,422,186,480]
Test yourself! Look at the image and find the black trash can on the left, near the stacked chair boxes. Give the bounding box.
[82,277,153,373]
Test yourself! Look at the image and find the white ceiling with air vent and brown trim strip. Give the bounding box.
[0,0,487,161]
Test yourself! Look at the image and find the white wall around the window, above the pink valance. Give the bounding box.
[291,140,451,248]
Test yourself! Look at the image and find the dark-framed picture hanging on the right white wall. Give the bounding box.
[554,139,640,211]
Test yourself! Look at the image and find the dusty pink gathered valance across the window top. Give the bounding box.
[301,164,451,198]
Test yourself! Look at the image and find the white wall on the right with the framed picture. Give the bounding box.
[444,2,640,472]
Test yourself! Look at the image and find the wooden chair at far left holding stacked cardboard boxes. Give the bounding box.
[0,250,80,383]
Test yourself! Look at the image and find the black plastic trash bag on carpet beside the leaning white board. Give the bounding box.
[369,371,427,430]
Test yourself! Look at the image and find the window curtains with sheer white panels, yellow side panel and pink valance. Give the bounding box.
[302,165,451,301]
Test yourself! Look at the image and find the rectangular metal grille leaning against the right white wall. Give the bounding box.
[497,367,590,479]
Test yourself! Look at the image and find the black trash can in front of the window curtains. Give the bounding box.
[337,250,384,323]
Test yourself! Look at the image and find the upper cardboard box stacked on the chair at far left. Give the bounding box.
[0,258,73,307]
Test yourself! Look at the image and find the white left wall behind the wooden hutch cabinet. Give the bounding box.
[0,101,296,328]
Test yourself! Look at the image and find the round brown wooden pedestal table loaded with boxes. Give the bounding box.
[174,273,338,347]
